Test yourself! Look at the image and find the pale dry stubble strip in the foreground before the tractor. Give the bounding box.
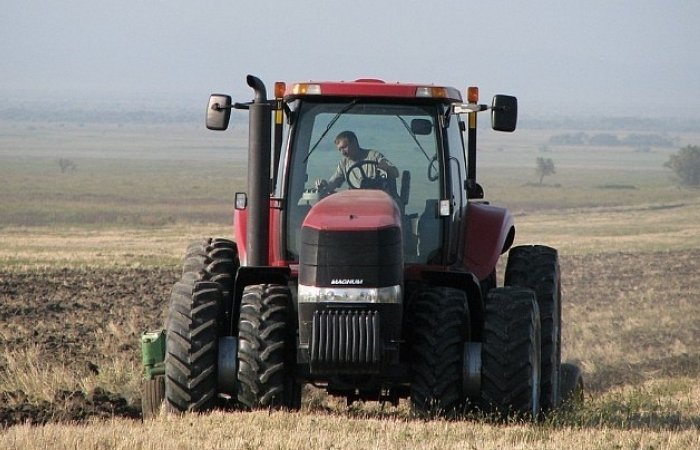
[0,411,700,450]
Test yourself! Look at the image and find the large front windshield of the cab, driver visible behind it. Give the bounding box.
[286,100,441,263]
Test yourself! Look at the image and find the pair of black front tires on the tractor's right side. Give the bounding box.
[407,287,541,417]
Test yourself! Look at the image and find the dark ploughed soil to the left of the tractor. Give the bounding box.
[0,269,177,426]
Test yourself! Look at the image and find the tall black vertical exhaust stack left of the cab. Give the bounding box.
[246,75,272,266]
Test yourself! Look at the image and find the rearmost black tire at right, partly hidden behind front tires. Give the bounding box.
[505,245,561,412]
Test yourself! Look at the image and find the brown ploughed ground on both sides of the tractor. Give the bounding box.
[0,249,700,428]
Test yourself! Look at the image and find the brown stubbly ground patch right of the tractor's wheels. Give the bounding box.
[562,250,700,391]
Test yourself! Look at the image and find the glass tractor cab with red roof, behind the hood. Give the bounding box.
[273,79,516,265]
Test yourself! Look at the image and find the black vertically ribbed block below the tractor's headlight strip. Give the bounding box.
[310,310,382,373]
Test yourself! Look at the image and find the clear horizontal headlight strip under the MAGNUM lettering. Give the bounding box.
[298,284,401,303]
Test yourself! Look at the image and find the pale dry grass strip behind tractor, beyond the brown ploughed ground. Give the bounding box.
[0,198,700,270]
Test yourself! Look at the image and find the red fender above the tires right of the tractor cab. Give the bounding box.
[464,203,515,280]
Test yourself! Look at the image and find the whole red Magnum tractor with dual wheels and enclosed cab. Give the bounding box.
[142,76,582,417]
